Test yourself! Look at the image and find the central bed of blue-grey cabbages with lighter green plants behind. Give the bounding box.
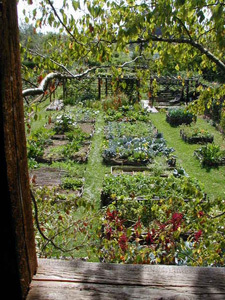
[102,121,174,166]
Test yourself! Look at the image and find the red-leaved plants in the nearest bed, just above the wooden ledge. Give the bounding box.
[100,208,185,264]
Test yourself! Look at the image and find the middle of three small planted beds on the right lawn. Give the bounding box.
[180,128,214,144]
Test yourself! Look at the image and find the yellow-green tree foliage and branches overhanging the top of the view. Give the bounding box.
[18,0,225,106]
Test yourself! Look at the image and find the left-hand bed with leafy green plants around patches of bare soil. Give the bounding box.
[28,114,95,163]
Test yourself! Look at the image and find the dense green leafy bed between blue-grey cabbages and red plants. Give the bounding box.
[101,172,205,206]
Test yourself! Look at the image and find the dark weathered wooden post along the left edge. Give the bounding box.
[0,0,37,299]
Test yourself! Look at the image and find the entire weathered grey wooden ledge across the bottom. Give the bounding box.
[27,259,225,300]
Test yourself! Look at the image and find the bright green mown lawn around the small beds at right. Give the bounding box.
[151,113,225,198]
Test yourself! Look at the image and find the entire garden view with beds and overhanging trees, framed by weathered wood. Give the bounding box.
[20,0,225,266]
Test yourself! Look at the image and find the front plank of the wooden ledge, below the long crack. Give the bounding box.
[27,282,219,300]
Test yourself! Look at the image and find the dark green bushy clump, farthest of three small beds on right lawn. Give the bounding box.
[166,108,195,126]
